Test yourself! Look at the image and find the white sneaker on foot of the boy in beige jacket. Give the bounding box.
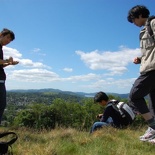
[139,127,155,141]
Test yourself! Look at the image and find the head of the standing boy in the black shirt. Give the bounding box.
[0,28,15,46]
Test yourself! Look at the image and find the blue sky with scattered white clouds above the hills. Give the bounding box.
[0,0,155,93]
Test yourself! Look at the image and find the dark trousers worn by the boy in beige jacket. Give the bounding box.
[129,70,155,114]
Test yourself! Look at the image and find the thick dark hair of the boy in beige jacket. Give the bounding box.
[127,5,150,23]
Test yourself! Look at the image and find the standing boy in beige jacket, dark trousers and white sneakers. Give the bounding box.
[127,5,155,143]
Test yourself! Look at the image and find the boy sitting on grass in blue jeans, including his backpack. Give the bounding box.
[90,92,135,133]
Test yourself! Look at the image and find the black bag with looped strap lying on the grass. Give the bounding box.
[0,132,18,155]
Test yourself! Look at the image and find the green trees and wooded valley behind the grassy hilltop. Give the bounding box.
[3,93,144,130]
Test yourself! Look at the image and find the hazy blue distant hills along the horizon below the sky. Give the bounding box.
[8,88,129,98]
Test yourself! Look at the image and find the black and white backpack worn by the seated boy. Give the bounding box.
[108,100,135,125]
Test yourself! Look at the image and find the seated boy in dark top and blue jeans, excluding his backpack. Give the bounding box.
[90,92,134,133]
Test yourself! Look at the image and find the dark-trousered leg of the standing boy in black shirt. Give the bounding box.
[0,83,6,124]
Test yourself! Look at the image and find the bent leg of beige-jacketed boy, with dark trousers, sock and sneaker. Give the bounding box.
[129,71,155,141]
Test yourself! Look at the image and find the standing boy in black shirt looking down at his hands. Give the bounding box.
[0,29,18,124]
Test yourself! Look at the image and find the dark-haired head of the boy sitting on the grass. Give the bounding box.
[94,91,109,106]
